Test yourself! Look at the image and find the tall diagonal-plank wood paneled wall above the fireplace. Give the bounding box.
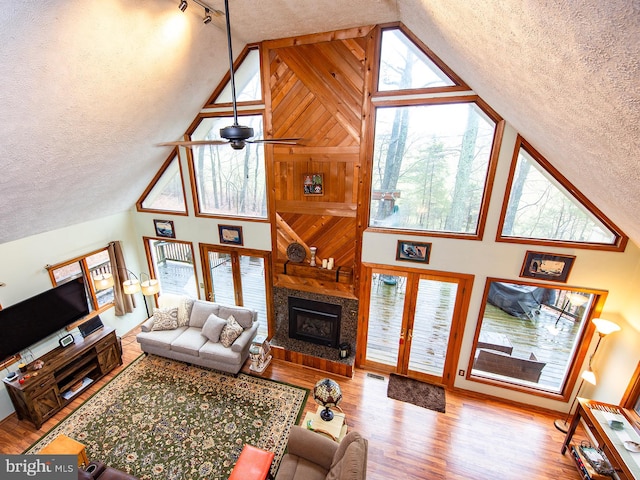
[262,27,372,292]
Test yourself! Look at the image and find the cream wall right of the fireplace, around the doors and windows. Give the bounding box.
[362,125,640,411]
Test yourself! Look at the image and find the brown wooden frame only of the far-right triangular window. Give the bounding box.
[496,135,629,252]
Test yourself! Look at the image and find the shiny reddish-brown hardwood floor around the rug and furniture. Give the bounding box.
[0,331,584,480]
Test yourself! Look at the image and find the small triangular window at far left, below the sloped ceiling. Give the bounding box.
[136,151,187,215]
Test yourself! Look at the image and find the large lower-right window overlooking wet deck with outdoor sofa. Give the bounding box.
[469,279,606,396]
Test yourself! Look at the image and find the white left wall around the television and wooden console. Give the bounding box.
[0,212,147,418]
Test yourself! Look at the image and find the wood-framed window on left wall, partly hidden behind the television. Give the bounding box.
[47,247,113,314]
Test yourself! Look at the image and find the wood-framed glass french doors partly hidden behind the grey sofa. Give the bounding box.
[200,244,271,336]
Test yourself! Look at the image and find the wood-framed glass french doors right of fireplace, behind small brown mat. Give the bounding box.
[359,268,471,385]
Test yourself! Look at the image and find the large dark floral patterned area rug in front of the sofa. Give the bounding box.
[25,355,309,479]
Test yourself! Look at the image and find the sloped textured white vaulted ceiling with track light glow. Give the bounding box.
[0,0,640,248]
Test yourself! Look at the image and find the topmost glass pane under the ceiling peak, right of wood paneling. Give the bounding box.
[378,29,458,92]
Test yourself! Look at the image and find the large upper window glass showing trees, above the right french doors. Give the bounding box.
[369,103,496,235]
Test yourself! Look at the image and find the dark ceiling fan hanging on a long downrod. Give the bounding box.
[158,0,300,150]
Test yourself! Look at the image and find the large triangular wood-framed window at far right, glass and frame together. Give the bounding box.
[497,137,627,250]
